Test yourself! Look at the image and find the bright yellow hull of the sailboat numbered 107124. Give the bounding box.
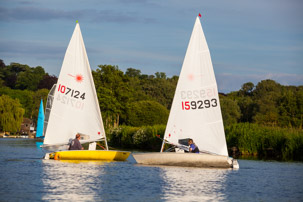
[49,150,130,161]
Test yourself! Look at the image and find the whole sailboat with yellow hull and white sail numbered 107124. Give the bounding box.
[42,22,130,160]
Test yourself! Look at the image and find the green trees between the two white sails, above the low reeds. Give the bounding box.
[93,65,178,128]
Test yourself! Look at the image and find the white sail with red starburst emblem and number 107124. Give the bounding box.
[44,23,106,146]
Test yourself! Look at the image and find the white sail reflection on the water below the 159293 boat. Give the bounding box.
[162,167,231,201]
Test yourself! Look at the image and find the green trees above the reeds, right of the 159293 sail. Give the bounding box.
[228,80,303,129]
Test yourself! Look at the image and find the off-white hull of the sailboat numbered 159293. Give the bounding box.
[132,152,239,168]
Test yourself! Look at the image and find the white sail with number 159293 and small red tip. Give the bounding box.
[164,17,228,156]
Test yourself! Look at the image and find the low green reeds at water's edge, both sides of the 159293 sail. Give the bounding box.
[107,123,303,161]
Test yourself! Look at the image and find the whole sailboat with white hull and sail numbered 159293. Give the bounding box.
[133,14,238,167]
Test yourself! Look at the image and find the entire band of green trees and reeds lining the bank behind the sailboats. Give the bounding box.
[0,59,303,161]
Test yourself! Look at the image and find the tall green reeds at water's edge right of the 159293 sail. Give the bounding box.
[225,123,303,161]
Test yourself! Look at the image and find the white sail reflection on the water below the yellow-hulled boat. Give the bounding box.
[42,160,107,201]
